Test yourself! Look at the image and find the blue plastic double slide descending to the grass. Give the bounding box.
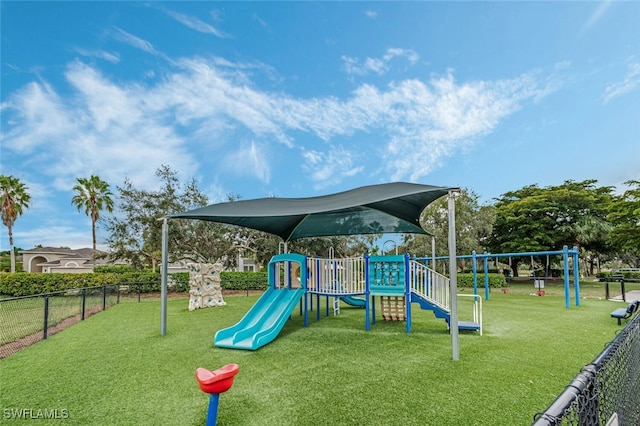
[213,287,305,351]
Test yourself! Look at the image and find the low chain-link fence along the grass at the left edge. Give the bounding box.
[0,283,158,359]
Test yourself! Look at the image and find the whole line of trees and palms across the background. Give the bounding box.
[0,165,640,274]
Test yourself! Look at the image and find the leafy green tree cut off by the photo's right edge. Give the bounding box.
[608,180,640,267]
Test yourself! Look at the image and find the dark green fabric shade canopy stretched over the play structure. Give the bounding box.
[169,182,457,241]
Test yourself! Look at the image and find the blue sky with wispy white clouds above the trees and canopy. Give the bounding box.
[0,1,640,249]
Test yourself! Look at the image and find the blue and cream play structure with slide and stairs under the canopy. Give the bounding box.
[214,253,482,350]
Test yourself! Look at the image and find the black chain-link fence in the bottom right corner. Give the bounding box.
[533,315,640,426]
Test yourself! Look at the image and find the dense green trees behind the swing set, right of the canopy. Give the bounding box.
[403,180,640,275]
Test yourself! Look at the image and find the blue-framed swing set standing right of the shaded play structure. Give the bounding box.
[416,246,580,308]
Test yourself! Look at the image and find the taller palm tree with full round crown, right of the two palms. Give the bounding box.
[71,175,113,267]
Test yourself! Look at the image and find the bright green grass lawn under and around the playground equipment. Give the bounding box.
[0,287,632,425]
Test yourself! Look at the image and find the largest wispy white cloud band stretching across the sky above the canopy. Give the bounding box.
[2,53,557,190]
